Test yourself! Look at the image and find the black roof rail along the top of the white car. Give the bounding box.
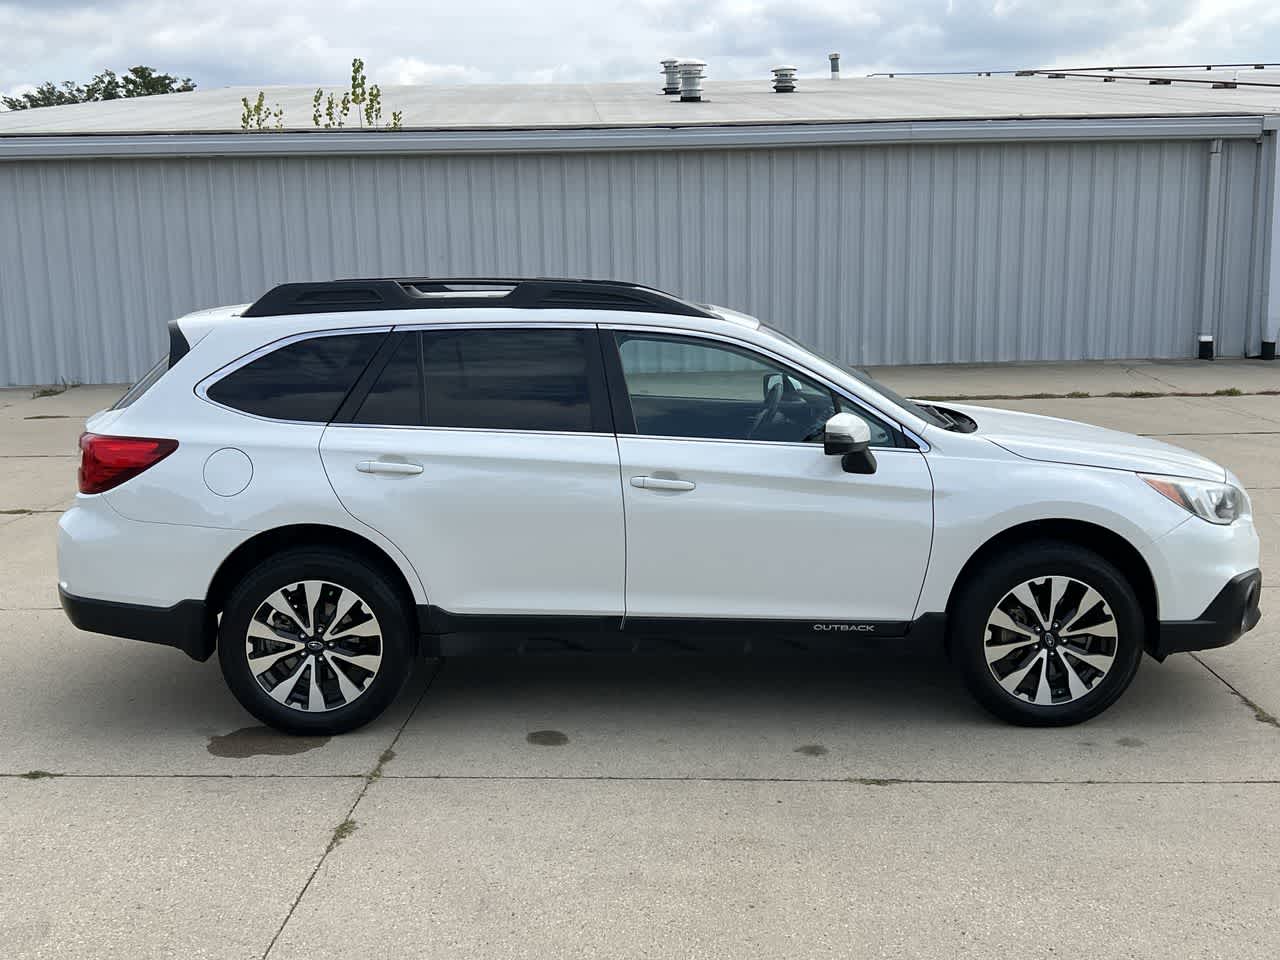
[242,276,716,317]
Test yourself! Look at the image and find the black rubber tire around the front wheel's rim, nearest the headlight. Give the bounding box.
[948,540,1144,727]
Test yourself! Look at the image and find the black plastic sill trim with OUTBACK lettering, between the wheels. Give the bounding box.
[417,605,946,657]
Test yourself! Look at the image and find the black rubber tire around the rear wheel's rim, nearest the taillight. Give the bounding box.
[218,547,413,736]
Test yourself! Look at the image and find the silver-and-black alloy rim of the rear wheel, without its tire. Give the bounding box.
[244,580,383,713]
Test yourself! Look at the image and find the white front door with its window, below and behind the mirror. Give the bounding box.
[605,329,933,635]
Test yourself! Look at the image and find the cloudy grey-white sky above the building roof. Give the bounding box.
[0,0,1280,92]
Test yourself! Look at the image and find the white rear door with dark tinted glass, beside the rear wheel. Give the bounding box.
[320,325,625,627]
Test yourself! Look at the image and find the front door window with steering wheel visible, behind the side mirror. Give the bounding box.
[617,334,893,447]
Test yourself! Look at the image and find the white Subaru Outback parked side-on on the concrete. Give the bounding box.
[59,279,1261,733]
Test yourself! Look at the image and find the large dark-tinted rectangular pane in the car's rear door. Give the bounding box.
[422,330,595,433]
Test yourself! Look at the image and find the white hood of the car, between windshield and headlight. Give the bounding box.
[941,403,1226,481]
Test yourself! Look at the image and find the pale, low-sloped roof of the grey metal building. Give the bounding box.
[0,73,1280,137]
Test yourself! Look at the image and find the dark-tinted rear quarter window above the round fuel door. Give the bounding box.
[209,333,387,424]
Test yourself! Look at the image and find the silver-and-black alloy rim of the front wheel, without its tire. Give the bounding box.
[983,576,1119,707]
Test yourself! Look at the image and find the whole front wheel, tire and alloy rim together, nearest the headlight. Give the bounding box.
[950,541,1143,726]
